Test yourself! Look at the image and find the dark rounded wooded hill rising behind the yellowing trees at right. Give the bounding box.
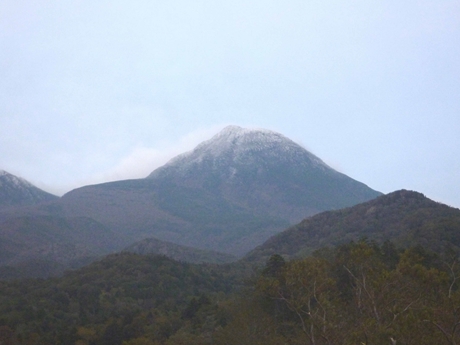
[243,190,460,263]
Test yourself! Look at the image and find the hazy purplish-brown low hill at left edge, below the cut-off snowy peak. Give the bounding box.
[0,216,121,279]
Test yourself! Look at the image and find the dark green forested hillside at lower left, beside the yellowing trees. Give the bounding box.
[0,253,241,345]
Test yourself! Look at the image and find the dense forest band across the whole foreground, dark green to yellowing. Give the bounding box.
[0,240,460,345]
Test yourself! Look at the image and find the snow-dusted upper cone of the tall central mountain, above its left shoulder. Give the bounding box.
[148,126,381,222]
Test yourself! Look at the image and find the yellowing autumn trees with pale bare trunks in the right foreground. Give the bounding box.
[250,241,460,345]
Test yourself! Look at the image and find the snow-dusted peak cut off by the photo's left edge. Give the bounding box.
[0,170,58,209]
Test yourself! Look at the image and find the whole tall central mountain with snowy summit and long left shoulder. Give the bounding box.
[59,126,381,256]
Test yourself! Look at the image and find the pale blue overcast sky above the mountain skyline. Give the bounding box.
[0,0,460,207]
